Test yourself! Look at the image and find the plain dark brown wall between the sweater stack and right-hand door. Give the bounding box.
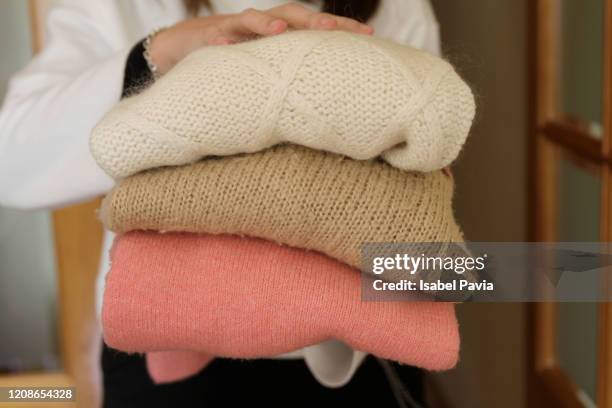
[432,0,529,408]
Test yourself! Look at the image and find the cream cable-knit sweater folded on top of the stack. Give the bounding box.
[91,31,475,178]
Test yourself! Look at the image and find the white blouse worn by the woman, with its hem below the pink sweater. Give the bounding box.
[0,0,440,387]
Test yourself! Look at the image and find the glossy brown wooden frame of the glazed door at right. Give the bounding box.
[527,0,612,408]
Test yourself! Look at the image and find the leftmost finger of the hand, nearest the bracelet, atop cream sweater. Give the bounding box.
[223,9,287,36]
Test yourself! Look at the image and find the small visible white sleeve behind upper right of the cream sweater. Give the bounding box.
[369,0,441,55]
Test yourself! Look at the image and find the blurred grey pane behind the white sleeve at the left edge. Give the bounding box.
[0,0,58,373]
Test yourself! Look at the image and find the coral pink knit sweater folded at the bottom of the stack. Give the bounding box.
[102,232,459,381]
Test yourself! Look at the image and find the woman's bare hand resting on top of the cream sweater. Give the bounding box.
[150,3,374,74]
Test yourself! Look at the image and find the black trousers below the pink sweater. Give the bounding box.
[102,345,423,408]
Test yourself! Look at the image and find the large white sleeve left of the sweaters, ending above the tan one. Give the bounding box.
[0,0,129,208]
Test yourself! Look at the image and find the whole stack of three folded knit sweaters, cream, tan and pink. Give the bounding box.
[91,31,474,382]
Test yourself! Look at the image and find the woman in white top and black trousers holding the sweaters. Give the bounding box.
[0,0,439,407]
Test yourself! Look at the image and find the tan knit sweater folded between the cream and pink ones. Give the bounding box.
[100,145,462,267]
